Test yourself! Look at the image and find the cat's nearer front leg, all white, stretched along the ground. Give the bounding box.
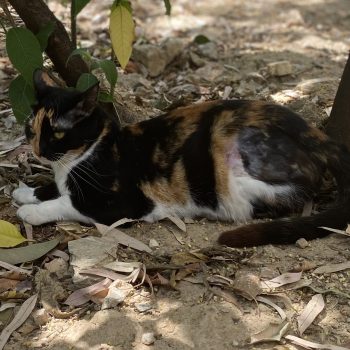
[17,195,95,225]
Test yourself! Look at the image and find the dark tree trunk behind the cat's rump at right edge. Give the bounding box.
[326,54,350,150]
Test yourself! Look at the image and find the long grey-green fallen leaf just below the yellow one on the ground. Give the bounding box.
[0,238,60,264]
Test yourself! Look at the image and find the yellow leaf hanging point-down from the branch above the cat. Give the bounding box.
[109,4,134,68]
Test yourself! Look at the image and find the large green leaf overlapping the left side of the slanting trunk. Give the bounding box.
[6,28,43,85]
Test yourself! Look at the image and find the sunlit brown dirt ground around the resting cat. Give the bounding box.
[0,0,350,350]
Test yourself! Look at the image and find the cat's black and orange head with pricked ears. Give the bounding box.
[25,70,98,162]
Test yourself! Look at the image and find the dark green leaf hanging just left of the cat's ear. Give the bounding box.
[9,75,35,123]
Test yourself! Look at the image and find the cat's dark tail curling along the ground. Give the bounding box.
[218,141,350,247]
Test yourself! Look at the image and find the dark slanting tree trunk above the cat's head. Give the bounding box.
[9,0,89,86]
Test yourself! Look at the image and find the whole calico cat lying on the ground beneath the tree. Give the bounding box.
[13,70,350,247]
